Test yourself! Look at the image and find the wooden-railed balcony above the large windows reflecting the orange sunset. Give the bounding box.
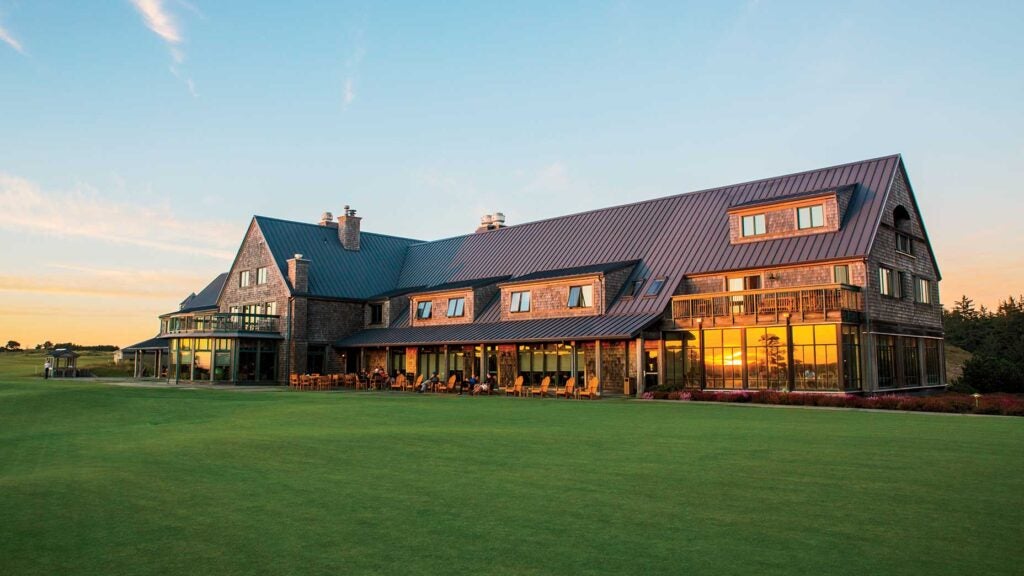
[672,284,864,328]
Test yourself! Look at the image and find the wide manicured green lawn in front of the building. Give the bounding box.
[0,376,1024,575]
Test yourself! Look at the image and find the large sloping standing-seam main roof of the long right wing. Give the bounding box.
[397,155,901,316]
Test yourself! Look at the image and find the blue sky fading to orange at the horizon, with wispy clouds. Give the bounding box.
[0,0,1024,346]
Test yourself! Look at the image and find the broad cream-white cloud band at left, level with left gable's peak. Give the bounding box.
[0,172,239,259]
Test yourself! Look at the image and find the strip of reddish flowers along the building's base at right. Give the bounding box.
[641,390,1024,416]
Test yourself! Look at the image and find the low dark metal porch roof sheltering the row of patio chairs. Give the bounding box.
[336,314,659,347]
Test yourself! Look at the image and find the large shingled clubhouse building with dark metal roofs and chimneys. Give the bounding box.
[142,155,945,396]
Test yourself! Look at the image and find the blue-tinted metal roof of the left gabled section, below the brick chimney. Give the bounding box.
[255,216,421,300]
